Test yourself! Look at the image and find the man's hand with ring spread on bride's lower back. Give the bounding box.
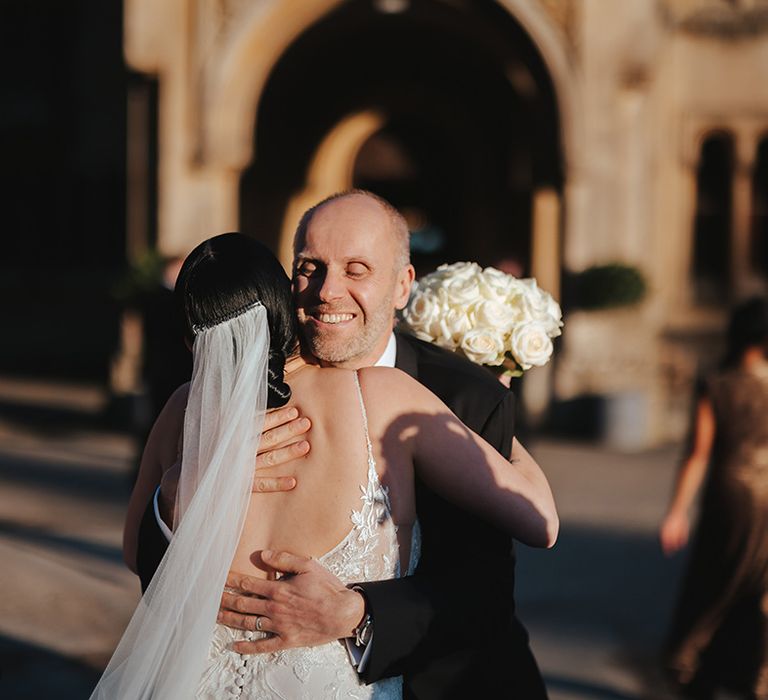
[218,550,365,654]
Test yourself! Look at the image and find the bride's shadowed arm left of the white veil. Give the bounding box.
[123,384,189,573]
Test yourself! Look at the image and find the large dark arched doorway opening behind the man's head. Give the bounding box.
[240,0,564,274]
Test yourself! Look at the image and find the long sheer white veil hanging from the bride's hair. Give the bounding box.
[91,303,269,700]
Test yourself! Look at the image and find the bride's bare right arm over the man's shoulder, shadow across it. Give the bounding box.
[365,369,559,547]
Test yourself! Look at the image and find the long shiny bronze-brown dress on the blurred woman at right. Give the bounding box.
[666,366,768,700]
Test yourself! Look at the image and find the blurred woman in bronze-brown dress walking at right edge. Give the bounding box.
[661,298,768,700]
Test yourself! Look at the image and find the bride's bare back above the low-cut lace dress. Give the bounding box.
[232,362,416,575]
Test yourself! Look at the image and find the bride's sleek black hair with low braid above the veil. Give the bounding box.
[174,233,297,408]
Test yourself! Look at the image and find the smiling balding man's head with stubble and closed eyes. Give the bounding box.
[293,194,413,368]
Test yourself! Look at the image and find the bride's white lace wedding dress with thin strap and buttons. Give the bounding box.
[197,372,420,700]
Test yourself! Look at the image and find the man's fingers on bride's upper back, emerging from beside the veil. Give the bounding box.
[253,406,312,492]
